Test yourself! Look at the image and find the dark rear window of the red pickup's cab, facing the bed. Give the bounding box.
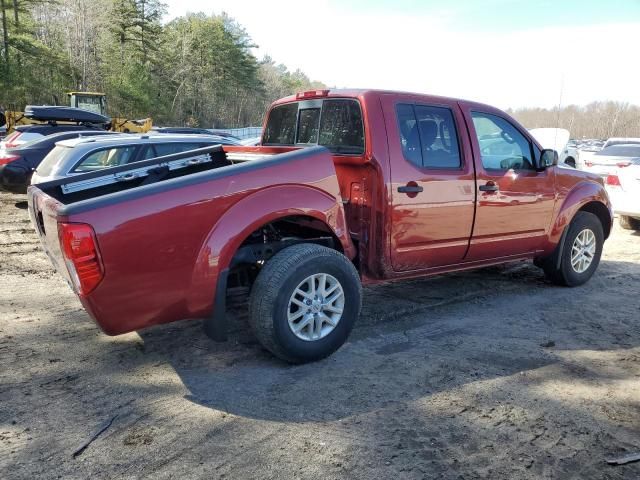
[263,100,364,155]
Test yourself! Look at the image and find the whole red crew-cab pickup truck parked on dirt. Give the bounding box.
[29,90,613,362]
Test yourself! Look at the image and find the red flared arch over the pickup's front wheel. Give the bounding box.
[546,181,613,251]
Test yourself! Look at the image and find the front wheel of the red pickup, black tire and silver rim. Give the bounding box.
[543,212,604,287]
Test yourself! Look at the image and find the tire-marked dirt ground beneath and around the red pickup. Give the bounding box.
[0,189,640,479]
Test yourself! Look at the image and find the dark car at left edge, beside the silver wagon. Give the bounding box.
[0,129,117,193]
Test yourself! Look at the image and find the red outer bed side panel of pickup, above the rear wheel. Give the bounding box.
[63,147,352,334]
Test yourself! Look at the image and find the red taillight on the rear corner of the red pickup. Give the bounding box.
[59,223,104,295]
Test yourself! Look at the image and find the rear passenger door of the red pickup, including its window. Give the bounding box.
[381,95,475,271]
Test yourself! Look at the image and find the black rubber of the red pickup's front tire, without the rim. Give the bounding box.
[543,212,604,287]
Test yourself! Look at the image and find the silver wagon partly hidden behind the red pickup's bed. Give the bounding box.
[31,134,237,184]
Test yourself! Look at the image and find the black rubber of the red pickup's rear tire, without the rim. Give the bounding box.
[249,243,362,363]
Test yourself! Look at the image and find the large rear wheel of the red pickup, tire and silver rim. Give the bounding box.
[249,244,362,363]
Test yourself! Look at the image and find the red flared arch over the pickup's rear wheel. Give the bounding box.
[187,185,356,316]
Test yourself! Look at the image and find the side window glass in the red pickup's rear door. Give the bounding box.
[396,104,462,168]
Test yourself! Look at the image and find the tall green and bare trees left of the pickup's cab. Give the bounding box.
[0,0,324,127]
